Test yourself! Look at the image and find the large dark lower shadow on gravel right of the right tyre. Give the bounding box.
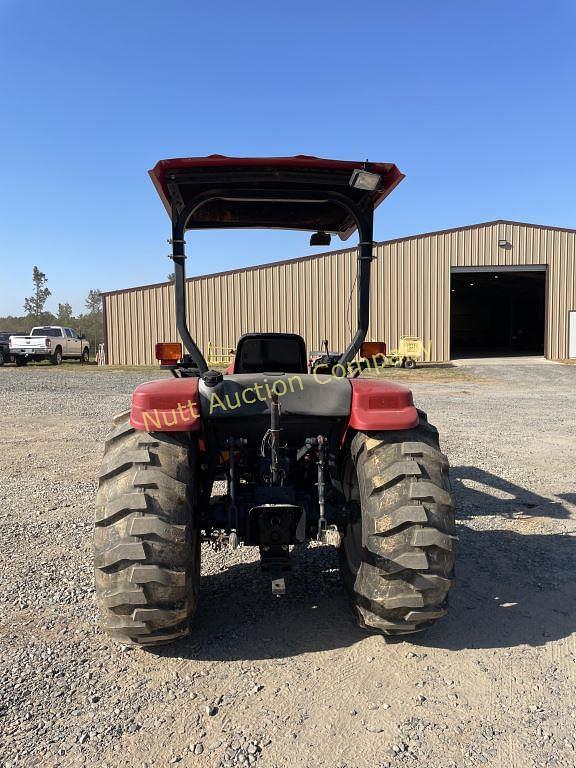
[422,520,576,650]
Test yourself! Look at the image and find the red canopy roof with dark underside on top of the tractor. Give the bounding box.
[149,155,404,240]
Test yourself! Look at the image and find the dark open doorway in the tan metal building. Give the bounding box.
[450,270,546,357]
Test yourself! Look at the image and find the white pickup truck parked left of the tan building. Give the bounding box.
[9,325,90,365]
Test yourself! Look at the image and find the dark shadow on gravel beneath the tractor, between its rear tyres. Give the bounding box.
[150,545,367,661]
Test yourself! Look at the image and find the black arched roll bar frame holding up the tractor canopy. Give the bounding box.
[170,189,374,374]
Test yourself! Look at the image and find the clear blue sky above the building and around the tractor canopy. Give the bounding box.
[0,0,576,315]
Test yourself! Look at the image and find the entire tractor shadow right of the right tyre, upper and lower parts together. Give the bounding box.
[423,466,576,650]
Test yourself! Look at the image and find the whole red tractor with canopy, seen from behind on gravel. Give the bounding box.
[94,155,457,646]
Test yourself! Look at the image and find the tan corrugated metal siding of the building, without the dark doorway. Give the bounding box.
[104,222,576,365]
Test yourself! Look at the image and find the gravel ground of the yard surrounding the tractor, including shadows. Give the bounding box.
[0,364,576,768]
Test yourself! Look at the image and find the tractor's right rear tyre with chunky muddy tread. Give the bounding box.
[340,412,457,635]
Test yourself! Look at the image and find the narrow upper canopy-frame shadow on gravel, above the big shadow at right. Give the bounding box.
[450,466,576,519]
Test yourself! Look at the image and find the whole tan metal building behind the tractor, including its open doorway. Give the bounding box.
[104,220,576,365]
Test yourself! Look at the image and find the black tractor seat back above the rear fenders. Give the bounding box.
[233,333,308,373]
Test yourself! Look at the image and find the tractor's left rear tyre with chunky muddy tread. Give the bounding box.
[94,412,200,646]
